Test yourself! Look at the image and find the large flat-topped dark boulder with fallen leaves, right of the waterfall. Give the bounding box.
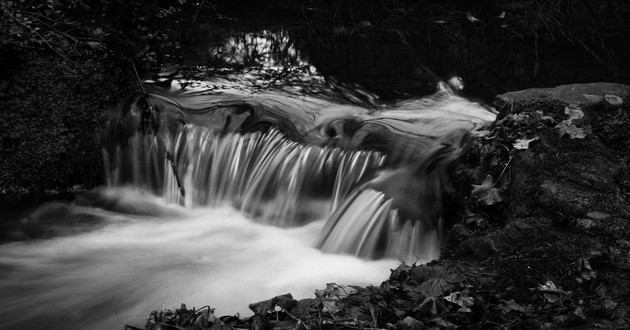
[493,83,630,222]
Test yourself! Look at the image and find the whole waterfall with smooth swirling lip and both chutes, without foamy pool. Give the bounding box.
[104,83,494,262]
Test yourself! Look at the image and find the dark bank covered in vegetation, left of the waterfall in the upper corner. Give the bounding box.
[0,0,217,206]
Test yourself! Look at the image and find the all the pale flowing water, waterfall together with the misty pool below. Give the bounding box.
[0,78,494,329]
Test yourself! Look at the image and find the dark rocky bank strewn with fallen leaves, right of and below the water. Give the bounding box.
[128,83,630,330]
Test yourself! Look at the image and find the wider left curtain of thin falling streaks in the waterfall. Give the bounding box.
[105,125,385,227]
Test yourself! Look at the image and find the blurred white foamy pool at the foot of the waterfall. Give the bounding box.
[0,188,397,329]
